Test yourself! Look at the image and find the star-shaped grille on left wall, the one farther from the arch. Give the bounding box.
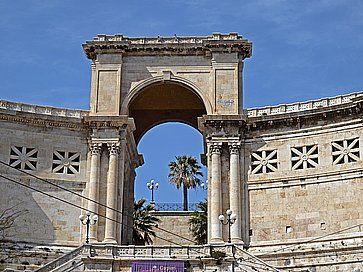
[9,146,38,171]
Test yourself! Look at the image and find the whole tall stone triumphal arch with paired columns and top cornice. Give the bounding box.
[83,33,252,243]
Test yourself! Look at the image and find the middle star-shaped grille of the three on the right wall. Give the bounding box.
[291,145,319,170]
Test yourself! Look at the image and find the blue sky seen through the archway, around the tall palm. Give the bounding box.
[135,122,207,207]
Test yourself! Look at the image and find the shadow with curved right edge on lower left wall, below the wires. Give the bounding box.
[0,179,55,243]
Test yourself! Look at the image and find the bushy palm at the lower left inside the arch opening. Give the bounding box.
[132,199,160,245]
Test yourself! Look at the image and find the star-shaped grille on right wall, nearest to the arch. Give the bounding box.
[251,150,278,174]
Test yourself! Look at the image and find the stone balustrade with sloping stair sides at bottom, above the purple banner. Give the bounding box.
[28,244,279,272]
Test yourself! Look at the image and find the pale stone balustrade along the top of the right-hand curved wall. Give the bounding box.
[247,92,363,117]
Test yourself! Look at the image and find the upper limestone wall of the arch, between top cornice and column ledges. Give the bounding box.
[91,54,243,115]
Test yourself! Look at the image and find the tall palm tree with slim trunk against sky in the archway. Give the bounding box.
[168,155,203,211]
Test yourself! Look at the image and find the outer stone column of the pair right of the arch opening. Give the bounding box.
[229,143,243,244]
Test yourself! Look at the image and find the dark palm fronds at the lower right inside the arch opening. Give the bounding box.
[189,199,208,245]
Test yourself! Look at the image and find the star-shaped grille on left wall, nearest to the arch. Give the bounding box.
[52,150,81,174]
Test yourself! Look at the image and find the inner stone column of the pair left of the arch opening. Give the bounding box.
[103,143,120,244]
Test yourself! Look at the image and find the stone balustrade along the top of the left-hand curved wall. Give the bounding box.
[0,100,88,118]
